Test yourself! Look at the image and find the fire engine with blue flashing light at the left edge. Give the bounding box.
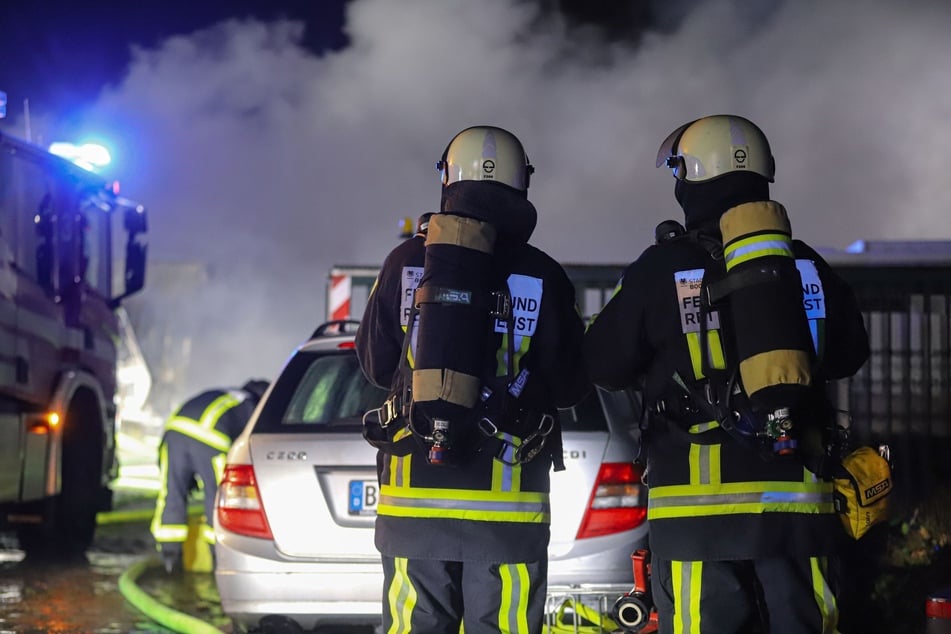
[0,134,147,555]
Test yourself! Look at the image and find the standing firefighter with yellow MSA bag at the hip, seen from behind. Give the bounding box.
[584,115,869,634]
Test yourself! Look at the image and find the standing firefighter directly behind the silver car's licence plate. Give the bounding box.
[356,126,591,634]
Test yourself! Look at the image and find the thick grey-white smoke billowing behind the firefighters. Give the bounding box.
[76,0,951,404]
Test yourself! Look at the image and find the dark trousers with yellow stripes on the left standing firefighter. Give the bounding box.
[383,555,548,634]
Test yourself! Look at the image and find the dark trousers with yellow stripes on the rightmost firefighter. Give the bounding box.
[651,556,839,634]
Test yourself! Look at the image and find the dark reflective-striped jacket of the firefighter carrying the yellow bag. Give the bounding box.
[584,212,869,561]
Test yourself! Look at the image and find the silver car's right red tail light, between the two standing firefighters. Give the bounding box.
[577,462,647,539]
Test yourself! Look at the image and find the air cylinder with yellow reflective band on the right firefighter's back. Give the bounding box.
[720,201,814,414]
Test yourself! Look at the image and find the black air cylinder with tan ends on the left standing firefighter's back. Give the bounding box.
[413,213,496,454]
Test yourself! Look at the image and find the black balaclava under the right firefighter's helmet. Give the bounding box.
[674,172,769,231]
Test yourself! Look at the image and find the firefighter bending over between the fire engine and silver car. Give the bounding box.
[151,379,268,572]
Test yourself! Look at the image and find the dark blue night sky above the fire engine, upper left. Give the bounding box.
[0,0,347,116]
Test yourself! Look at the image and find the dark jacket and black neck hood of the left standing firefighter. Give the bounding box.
[356,181,590,563]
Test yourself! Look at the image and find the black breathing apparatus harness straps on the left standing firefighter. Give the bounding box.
[363,278,564,471]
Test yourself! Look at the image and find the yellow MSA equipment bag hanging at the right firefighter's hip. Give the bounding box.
[835,446,892,539]
